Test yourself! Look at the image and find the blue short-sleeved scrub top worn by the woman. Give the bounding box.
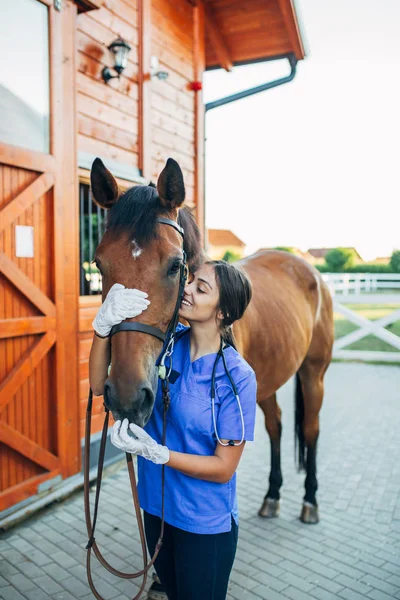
[138,324,257,534]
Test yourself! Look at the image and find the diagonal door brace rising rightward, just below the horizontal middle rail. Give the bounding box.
[0,331,56,413]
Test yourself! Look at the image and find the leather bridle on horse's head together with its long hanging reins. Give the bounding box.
[84,217,187,600]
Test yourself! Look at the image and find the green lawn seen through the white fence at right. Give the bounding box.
[334,304,400,352]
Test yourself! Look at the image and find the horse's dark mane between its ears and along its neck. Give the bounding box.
[107,185,203,271]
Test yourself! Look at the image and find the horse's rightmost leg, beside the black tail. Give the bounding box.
[296,357,329,523]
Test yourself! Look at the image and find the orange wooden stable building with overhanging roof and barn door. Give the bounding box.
[0,0,304,527]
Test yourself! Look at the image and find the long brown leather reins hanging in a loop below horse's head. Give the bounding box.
[84,380,170,600]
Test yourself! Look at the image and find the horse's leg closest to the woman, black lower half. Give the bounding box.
[258,394,283,519]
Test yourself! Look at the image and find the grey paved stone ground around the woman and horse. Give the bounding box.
[0,363,400,600]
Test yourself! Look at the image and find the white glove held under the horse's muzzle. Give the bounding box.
[111,419,169,465]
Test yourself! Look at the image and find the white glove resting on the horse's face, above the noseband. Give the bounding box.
[92,283,150,337]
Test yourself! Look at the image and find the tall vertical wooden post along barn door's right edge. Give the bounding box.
[52,1,81,477]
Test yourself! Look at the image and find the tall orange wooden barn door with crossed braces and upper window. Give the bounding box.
[0,0,79,511]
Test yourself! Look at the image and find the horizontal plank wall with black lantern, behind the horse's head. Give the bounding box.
[77,0,203,437]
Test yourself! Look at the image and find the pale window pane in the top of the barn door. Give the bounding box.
[0,0,50,153]
